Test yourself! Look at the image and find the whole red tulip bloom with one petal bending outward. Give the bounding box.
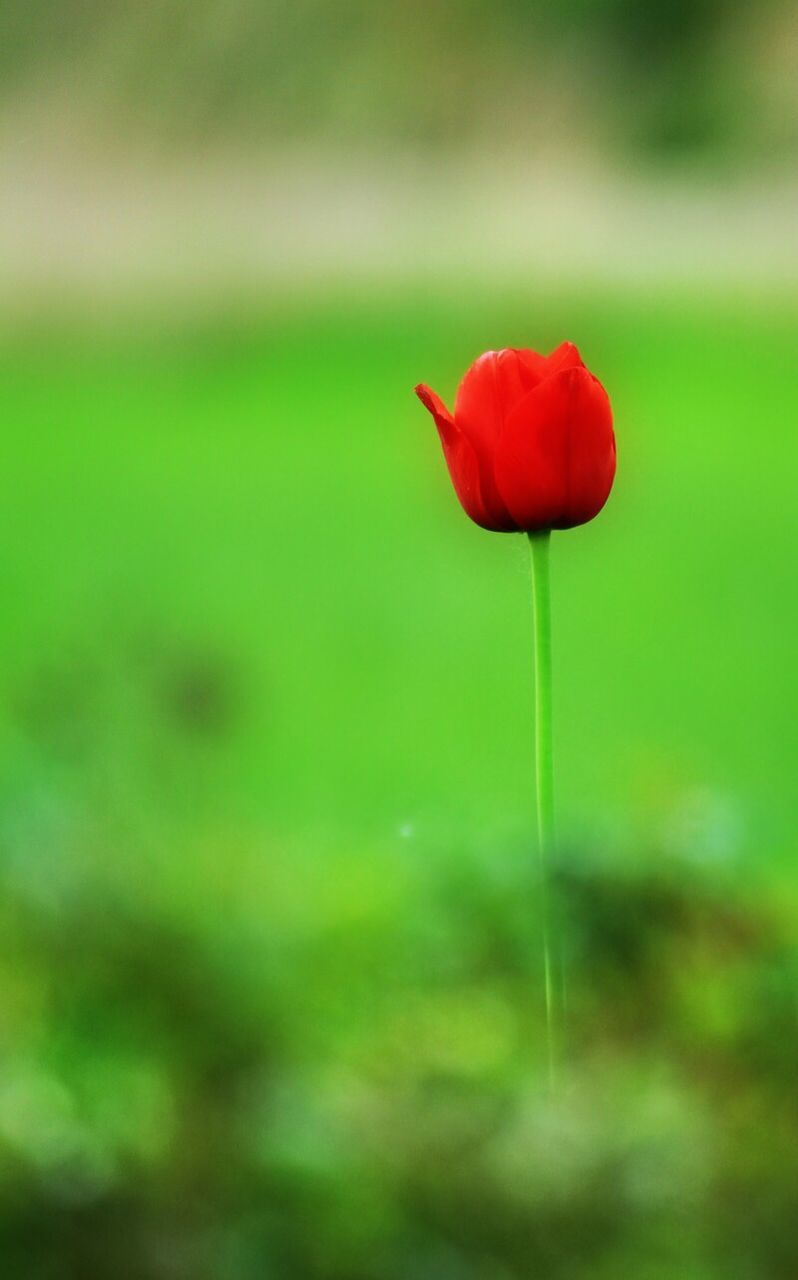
[415,342,615,532]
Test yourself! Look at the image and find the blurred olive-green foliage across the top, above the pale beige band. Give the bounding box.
[0,0,798,156]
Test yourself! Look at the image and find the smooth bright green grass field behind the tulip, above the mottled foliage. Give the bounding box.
[0,291,798,863]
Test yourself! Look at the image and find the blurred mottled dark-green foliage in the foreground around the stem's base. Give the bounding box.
[0,847,798,1280]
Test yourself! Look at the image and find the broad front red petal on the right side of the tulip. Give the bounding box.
[494,368,615,530]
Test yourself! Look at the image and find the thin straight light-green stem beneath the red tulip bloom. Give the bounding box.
[528,530,556,1089]
